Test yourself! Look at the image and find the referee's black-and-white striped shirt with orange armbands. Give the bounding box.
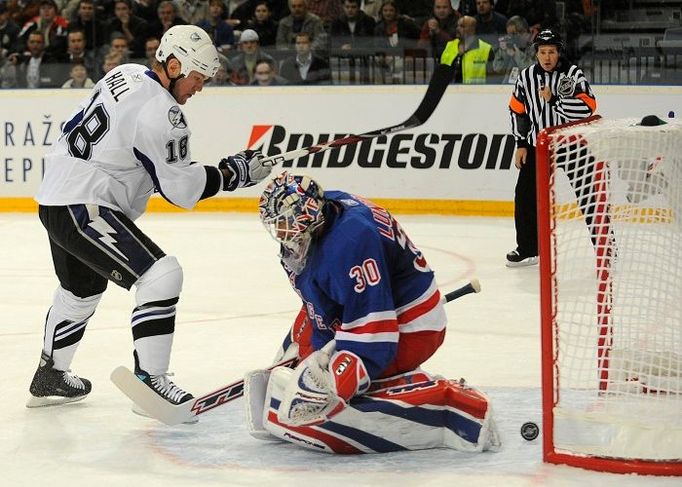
[509,58,597,147]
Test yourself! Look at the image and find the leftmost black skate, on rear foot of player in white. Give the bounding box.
[26,352,92,408]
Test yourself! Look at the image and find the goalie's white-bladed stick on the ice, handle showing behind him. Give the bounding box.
[111,279,481,426]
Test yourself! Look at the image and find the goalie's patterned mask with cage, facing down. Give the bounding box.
[259,172,324,274]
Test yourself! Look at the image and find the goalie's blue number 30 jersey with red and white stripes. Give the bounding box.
[285,191,447,379]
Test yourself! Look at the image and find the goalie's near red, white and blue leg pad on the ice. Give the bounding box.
[263,372,500,454]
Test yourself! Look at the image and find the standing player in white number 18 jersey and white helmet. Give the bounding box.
[27,25,271,407]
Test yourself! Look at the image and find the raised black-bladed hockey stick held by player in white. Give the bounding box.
[262,64,455,166]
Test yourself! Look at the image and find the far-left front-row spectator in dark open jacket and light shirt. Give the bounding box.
[8,30,59,88]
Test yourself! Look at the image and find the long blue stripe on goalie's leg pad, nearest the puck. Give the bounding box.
[351,396,481,443]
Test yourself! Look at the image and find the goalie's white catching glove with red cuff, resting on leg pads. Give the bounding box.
[270,340,370,426]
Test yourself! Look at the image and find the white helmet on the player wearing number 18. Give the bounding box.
[156,25,220,78]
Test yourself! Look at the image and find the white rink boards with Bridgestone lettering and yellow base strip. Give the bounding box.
[0,85,682,214]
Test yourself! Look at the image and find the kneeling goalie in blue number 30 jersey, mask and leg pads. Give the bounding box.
[244,172,500,454]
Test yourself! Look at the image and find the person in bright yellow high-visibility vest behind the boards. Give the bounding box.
[440,15,494,84]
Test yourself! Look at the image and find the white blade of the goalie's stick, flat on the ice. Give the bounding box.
[110,366,194,426]
